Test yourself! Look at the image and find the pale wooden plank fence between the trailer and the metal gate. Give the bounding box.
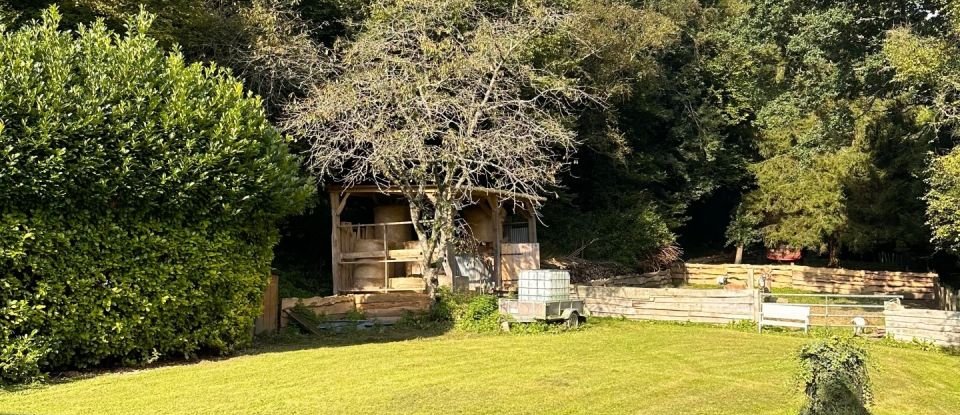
[574,285,759,324]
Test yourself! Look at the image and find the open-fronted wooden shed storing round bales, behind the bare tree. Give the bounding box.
[327,185,543,294]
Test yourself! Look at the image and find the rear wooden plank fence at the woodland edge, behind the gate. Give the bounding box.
[670,264,939,301]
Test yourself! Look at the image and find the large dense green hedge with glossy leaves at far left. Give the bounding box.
[0,9,313,382]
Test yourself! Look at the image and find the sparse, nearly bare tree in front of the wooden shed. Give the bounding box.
[285,0,598,284]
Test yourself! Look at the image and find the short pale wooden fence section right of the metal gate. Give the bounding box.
[883,307,960,347]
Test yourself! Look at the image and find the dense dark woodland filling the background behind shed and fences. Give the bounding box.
[7,0,960,291]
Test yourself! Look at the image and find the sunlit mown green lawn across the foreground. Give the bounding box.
[0,321,960,415]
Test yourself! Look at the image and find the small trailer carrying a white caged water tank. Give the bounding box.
[498,269,583,330]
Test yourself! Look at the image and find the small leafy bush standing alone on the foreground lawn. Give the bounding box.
[798,336,871,415]
